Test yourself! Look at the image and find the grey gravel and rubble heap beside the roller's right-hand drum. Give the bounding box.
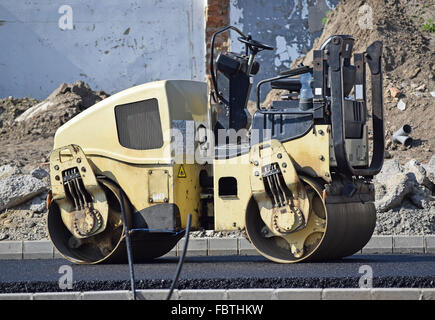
[375,156,435,235]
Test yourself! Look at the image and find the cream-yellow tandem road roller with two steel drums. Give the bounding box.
[47,26,384,264]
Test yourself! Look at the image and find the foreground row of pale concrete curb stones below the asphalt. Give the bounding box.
[0,288,435,301]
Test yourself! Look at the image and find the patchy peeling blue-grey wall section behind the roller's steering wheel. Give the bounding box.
[230,0,339,100]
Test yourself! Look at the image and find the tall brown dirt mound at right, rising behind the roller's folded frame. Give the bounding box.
[263,0,435,164]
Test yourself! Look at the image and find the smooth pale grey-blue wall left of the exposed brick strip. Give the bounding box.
[0,0,206,99]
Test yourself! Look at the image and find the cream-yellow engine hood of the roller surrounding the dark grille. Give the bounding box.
[54,80,208,164]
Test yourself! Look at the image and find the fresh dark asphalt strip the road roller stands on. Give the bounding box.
[0,254,435,293]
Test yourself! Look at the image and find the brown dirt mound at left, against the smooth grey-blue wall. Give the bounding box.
[0,81,108,171]
